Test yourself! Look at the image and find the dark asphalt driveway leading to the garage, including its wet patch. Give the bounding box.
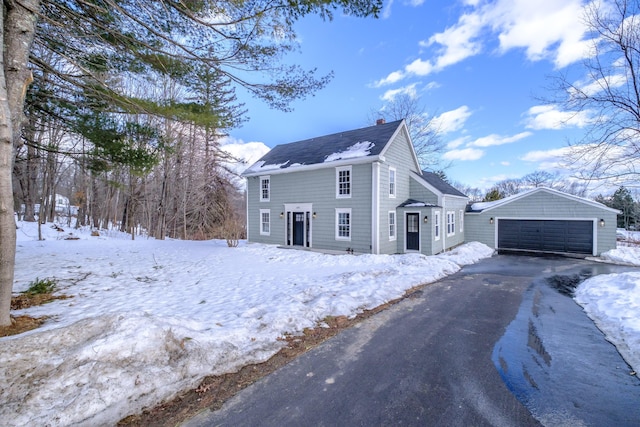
[184,255,640,426]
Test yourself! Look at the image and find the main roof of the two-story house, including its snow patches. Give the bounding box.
[242,120,403,176]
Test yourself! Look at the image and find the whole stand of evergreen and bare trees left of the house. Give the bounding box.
[0,0,382,326]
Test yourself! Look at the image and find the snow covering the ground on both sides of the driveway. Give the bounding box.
[0,223,640,426]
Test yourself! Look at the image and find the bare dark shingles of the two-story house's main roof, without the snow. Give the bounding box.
[245,120,402,173]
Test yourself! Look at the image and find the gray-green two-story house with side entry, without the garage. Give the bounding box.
[243,120,468,255]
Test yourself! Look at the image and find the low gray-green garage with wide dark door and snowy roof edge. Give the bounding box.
[465,188,618,256]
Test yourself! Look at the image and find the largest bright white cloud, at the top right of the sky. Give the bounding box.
[376,0,593,87]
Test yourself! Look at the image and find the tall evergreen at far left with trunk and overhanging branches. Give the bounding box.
[0,0,382,326]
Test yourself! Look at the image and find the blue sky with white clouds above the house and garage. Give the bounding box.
[225,0,586,189]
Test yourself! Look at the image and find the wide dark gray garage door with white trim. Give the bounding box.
[498,219,593,254]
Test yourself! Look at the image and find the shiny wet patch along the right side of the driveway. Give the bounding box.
[492,264,640,426]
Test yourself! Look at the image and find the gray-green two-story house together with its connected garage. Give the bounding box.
[243,120,618,255]
